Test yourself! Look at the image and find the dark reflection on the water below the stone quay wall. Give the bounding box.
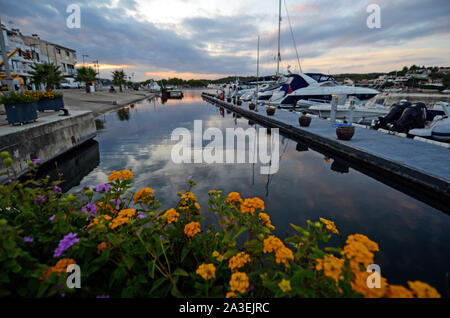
[37,140,100,192]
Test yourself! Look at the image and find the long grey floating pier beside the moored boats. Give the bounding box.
[202,93,450,202]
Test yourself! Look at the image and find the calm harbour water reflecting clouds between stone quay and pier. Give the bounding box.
[65,92,450,293]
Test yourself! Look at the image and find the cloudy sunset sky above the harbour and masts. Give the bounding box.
[0,0,450,80]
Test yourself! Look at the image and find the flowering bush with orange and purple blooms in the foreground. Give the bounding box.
[0,154,440,298]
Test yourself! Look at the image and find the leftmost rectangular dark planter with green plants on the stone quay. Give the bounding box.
[0,92,38,125]
